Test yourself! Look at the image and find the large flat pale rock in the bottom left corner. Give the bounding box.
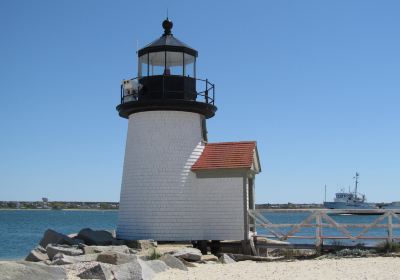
[0,261,67,280]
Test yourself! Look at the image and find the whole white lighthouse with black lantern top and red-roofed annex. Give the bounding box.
[117,18,261,241]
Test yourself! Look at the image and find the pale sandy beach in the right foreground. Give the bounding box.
[155,257,400,280]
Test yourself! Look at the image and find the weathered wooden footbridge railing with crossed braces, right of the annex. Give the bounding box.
[248,209,400,248]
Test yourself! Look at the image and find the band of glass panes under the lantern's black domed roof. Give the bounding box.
[138,51,196,78]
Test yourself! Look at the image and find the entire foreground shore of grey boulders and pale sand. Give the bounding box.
[0,228,400,280]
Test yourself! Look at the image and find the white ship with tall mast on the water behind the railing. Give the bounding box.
[324,172,378,209]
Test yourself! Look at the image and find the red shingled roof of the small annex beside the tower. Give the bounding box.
[192,141,256,171]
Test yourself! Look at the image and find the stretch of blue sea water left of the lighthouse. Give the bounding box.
[0,210,118,259]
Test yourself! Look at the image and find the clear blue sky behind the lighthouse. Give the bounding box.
[0,0,400,203]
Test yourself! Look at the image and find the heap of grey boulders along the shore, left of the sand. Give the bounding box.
[0,228,235,280]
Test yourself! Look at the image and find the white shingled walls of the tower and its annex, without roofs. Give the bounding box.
[117,111,244,241]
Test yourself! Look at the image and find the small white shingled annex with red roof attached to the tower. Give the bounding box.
[191,141,261,240]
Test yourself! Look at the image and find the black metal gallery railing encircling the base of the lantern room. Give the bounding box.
[121,75,215,105]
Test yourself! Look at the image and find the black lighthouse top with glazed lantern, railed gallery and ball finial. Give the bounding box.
[117,18,217,118]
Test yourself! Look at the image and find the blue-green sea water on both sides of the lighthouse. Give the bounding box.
[0,210,400,260]
